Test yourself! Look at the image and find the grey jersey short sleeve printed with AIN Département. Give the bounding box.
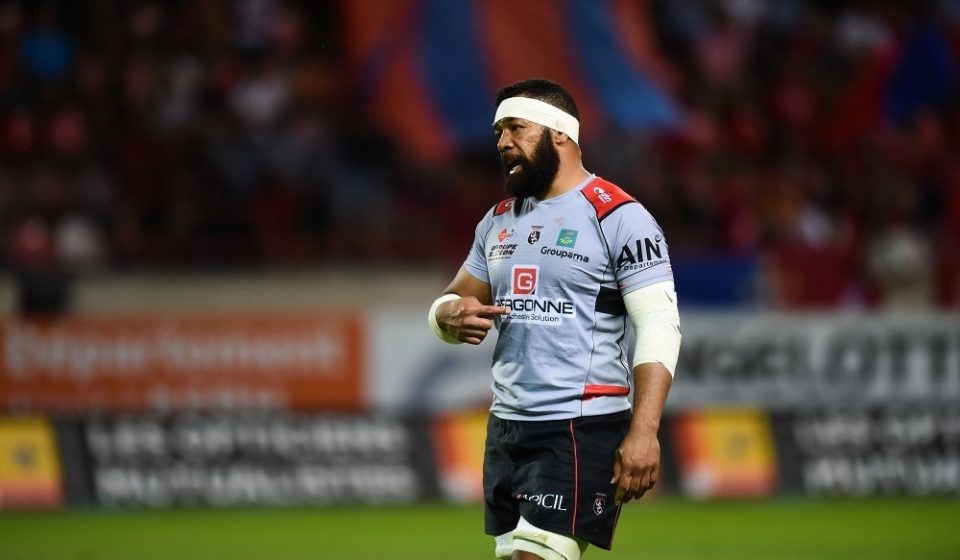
[600,203,673,294]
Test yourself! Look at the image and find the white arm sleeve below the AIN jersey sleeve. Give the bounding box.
[623,281,681,375]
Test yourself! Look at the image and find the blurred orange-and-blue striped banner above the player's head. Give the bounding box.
[342,0,680,157]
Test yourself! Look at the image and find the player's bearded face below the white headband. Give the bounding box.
[495,119,560,199]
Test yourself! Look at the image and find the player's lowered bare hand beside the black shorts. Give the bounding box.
[610,428,660,504]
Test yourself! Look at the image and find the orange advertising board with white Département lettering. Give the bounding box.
[0,312,366,412]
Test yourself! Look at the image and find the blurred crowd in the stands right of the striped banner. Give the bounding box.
[636,0,960,308]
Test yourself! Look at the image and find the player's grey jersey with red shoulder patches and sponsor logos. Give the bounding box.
[464,176,673,420]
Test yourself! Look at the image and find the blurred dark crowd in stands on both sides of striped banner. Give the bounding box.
[0,0,960,308]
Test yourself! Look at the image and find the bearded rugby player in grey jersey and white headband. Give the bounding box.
[427,79,680,560]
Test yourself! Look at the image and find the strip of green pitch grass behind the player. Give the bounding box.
[0,498,960,560]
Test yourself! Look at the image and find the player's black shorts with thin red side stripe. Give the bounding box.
[483,411,631,550]
